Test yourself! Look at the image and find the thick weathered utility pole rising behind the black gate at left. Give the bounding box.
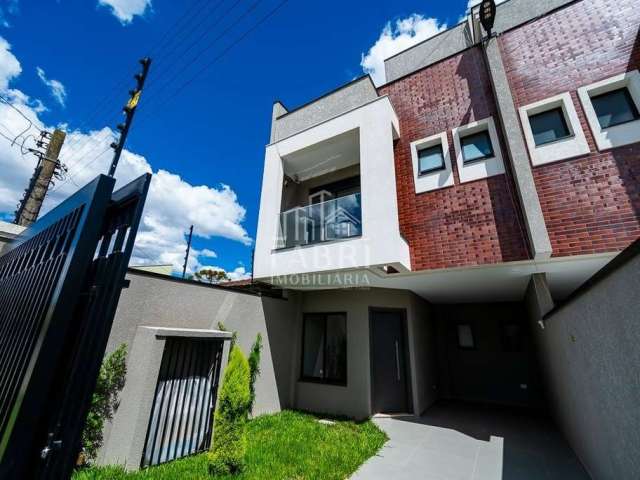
[15,129,66,227]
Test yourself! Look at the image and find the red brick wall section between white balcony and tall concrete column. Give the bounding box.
[379,48,528,270]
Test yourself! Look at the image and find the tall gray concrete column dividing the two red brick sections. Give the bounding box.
[484,37,552,260]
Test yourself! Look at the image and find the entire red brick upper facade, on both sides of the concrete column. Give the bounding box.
[379,0,640,270]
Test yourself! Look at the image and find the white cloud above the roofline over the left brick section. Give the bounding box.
[360,13,447,85]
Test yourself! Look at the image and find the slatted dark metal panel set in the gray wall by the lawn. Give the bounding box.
[140,338,223,467]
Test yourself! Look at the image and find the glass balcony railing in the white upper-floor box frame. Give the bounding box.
[278,193,362,248]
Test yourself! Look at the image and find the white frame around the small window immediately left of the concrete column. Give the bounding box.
[452,117,504,183]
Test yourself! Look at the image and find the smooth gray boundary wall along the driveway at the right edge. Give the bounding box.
[526,253,640,480]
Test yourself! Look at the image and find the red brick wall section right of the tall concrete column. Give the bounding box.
[500,0,640,256]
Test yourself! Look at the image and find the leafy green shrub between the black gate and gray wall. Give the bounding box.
[82,344,127,461]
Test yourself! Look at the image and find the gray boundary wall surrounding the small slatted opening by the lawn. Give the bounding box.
[98,270,298,469]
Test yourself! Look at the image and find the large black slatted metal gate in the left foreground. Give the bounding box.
[0,174,151,479]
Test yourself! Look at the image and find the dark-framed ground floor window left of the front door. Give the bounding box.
[301,313,347,385]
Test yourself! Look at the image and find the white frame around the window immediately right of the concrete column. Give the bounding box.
[518,92,590,166]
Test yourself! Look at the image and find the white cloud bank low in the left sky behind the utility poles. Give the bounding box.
[0,37,252,275]
